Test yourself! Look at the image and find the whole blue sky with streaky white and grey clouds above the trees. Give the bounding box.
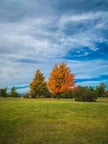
[0,0,108,93]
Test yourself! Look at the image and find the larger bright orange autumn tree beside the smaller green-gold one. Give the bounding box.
[47,63,75,98]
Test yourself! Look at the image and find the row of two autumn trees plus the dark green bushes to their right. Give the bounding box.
[24,63,106,101]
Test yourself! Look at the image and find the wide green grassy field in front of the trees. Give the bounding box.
[0,98,108,144]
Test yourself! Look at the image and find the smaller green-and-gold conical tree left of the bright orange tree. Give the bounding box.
[30,70,47,98]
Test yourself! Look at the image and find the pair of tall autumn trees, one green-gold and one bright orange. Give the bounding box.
[30,63,75,98]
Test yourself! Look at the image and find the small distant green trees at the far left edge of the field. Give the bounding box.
[0,87,18,97]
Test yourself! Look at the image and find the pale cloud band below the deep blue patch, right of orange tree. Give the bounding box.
[66,60,108,80]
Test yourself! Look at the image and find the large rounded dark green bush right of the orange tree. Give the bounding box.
[73,86,97,102]
